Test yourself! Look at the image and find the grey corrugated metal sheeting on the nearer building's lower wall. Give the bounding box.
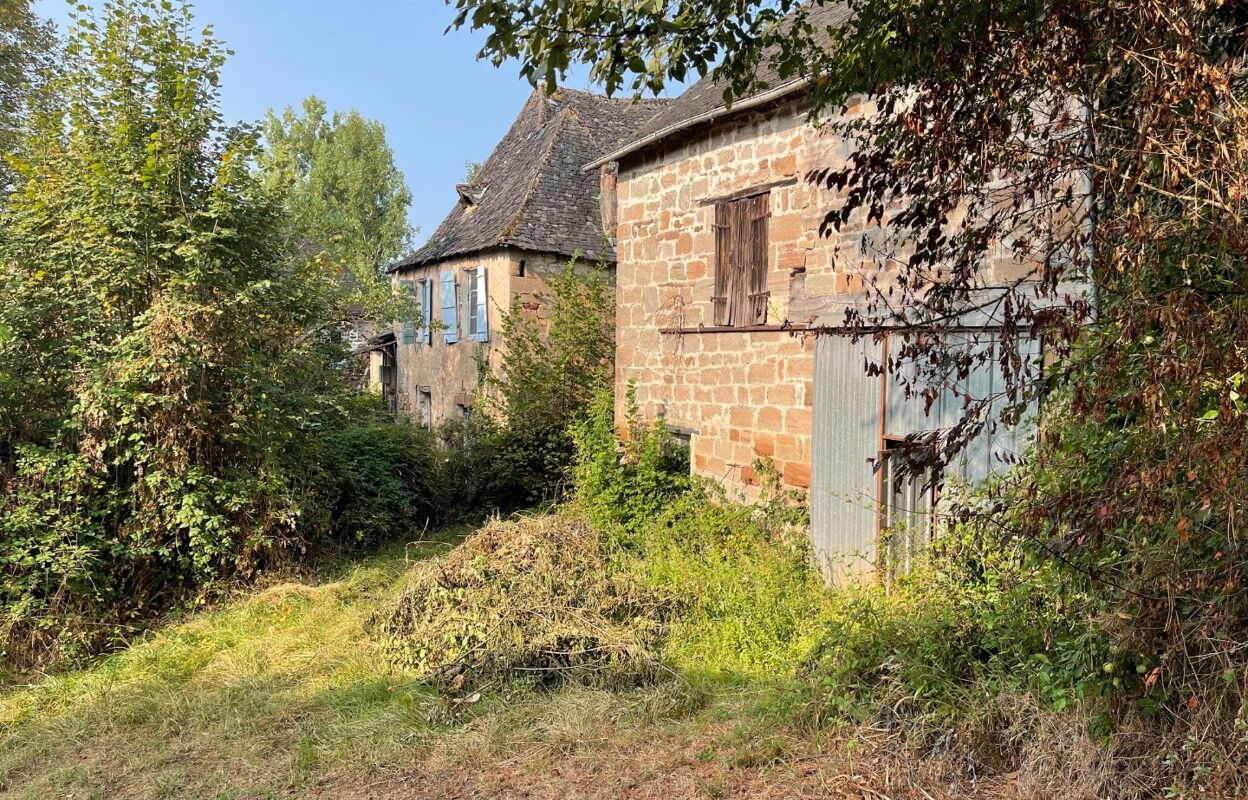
[811,331,1040,580]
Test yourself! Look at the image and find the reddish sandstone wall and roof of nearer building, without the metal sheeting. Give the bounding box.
[592,7,861,494]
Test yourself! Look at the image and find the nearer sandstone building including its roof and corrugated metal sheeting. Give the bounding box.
[587,6,1058,575]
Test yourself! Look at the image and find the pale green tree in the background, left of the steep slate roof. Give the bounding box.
[257,97,413,318]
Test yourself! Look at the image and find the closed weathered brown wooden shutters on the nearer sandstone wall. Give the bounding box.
[711,192,771,327]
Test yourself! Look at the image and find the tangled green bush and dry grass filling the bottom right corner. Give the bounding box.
[799,464,1248,800]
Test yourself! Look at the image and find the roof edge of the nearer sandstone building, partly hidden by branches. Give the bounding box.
[587,2,850,170]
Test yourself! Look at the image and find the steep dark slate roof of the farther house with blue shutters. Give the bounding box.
[388,89,671,272]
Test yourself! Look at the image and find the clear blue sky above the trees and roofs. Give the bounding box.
[35,0,683,243]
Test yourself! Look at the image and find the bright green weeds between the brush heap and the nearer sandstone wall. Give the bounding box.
[573,388,826,678]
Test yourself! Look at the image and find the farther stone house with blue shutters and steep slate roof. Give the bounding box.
[374,89,665,426]
